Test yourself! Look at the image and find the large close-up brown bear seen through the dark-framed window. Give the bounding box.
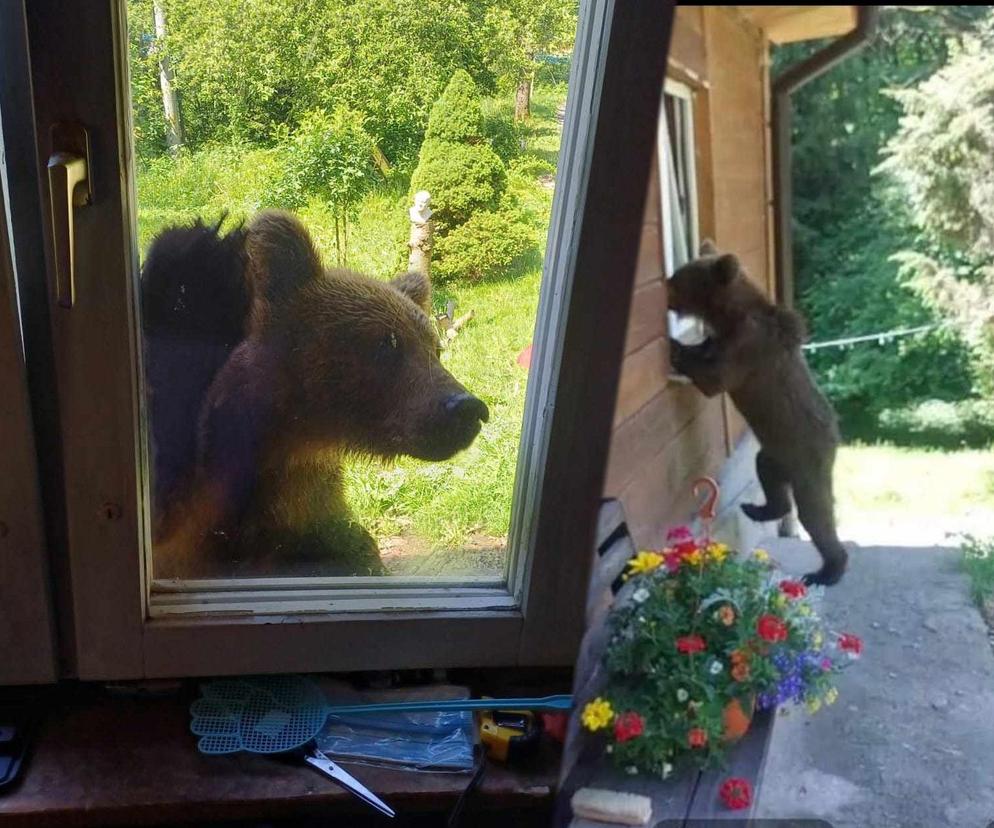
[142,211,489,578]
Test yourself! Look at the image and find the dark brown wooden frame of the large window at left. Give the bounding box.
[19,0,673,679]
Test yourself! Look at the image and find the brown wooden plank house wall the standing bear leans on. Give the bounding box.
[605,6,774,546]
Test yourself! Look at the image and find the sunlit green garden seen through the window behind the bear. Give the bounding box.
[128,0,577,576]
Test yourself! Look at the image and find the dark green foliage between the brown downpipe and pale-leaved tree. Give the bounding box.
[774,6,985,437]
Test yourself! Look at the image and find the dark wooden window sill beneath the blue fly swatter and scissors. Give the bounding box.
[0,684,560,828]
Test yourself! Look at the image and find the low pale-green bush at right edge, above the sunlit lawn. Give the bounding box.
[878,400,994,448]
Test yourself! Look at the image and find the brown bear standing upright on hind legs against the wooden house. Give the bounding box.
[668,242,847,585]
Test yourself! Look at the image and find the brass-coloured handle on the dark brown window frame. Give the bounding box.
[48,124,93,308]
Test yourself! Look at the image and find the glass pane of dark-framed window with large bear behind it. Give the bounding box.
[127,0,577,582]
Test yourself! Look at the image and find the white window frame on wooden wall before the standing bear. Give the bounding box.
[657,78,704,343]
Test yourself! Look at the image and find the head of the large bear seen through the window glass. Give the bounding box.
[246,212,489,460]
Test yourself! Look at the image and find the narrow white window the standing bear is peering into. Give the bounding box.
[658,78,704,344]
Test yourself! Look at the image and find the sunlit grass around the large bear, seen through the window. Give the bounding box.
[138,84,566,574]
